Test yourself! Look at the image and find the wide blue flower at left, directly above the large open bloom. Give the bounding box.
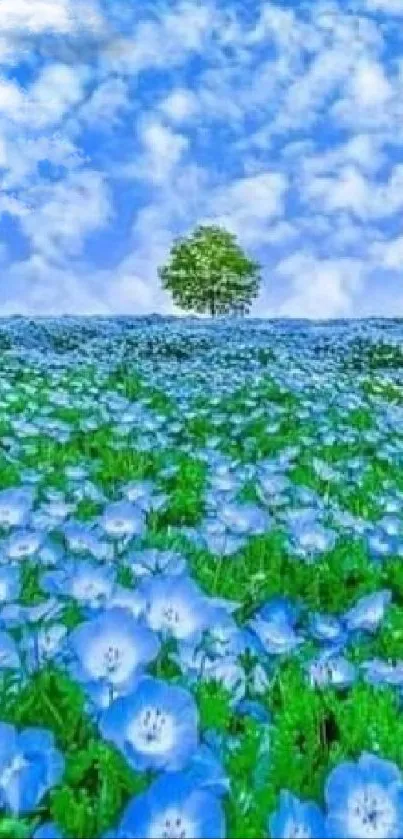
[41,559,116,609]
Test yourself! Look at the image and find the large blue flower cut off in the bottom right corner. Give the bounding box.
[325,752,403,839]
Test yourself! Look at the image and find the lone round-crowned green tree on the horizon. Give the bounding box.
[158,225,261,317]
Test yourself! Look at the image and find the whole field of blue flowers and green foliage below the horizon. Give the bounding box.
[0,316,403,839]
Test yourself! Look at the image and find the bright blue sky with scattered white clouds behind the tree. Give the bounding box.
[0,0,403,318]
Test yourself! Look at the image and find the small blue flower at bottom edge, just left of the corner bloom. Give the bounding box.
[269,790,328,839]
